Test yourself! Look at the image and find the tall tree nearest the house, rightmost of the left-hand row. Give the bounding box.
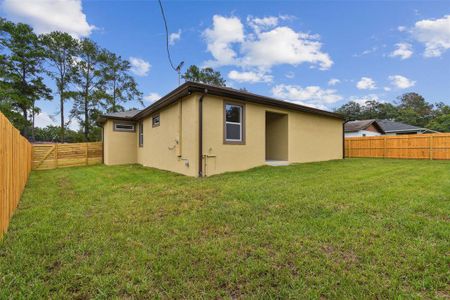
[98,52,143,112]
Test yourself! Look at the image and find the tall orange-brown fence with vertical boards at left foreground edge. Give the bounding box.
[0,113,31,238]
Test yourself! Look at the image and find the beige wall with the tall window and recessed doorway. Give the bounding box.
[203,96,343,176]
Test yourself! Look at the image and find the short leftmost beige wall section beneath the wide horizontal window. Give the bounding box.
[103,120,137,165]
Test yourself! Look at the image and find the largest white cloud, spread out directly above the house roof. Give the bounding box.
[203,15,333,70]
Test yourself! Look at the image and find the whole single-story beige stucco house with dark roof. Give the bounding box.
[99,82,344,177]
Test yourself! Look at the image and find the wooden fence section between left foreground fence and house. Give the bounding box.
[33,142,103,170]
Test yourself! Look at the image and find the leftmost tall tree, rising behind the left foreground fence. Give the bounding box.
[1,21,52,138]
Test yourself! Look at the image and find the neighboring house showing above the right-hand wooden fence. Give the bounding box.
[345,119,435,137]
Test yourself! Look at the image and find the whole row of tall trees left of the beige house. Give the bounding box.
[0,18,143,142]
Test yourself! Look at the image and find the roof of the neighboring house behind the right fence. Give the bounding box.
[345,119,428,133]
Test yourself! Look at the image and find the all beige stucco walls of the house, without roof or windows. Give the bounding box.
[104,93,343,176]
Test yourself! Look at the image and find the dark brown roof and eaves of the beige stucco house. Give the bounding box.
[98,81,343,123]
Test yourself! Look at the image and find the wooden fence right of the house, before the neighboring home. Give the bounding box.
[345,133,450,159]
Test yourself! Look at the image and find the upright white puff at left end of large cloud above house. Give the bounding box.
[203,15,244,65]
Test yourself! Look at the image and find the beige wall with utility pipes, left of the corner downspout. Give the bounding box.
[136,95,199,176]
